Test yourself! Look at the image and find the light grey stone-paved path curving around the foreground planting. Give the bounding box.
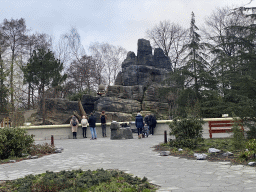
[0,135,256,192]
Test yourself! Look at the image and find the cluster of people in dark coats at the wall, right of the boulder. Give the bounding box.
[135,113,157,139]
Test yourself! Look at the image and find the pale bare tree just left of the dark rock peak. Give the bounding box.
[90,42,127,85]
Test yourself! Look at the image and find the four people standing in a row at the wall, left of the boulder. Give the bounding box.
[70,111,107,140]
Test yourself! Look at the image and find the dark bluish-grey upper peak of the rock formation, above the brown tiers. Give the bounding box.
[115,39,172,86]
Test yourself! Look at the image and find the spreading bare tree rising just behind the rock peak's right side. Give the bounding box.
[146,21,188,69]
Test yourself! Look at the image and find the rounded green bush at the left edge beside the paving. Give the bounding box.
[0,127,34,159]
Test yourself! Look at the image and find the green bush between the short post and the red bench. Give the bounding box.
[170,117,204,149]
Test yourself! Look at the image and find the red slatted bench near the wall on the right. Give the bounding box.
[209,120,244,138]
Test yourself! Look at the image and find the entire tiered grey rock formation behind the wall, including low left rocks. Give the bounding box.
[36,39,172,123]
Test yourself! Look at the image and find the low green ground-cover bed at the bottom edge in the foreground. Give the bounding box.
[0,169,158,192]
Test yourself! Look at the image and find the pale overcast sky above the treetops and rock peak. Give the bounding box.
[0,0,253,53]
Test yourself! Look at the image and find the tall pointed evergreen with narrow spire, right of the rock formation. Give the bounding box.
[174,12,216,116]
